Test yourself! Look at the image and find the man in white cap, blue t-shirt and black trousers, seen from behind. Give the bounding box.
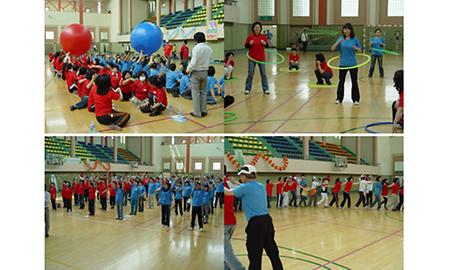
[225,165,283,270]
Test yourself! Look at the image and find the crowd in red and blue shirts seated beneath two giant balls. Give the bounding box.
[49,51,223,130]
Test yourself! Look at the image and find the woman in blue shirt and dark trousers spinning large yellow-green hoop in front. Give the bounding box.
[331,23,361,105]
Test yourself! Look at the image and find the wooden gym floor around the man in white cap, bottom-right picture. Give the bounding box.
[232,194,403,270]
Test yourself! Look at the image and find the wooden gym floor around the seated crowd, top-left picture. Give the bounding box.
[45,57,224,133]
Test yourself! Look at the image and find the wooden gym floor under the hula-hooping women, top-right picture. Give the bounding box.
[225,52,403,133]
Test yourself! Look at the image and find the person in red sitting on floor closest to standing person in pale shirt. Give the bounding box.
[139,76,167,116]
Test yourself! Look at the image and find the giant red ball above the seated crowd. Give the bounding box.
[59,23,92,55]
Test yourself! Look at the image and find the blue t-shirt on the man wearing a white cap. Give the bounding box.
[233,180,269,221]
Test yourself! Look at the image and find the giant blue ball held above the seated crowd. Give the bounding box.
[130,22,163,55]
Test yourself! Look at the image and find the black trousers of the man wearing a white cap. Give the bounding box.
[245,215,283,270]
